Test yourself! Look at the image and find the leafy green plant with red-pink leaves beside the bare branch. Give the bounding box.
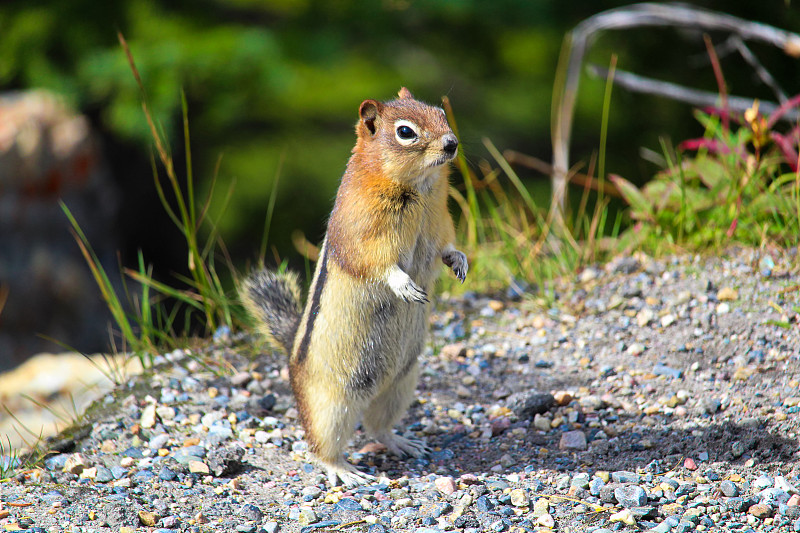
[611,95,800,247]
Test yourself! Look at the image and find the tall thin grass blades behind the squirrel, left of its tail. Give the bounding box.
[62,33,277,366]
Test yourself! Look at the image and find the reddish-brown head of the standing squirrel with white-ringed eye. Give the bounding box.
[354,87,458,187]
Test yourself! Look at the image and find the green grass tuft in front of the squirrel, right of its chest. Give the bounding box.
[443,59,622,296]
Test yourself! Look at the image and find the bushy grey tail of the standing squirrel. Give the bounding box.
[239,270,303,355]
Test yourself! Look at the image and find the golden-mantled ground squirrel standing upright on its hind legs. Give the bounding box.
[240,87,468,486]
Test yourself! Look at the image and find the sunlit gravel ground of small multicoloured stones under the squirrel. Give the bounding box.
[0,250,800,533]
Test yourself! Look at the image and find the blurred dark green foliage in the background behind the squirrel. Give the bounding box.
[0,0,800,272]
